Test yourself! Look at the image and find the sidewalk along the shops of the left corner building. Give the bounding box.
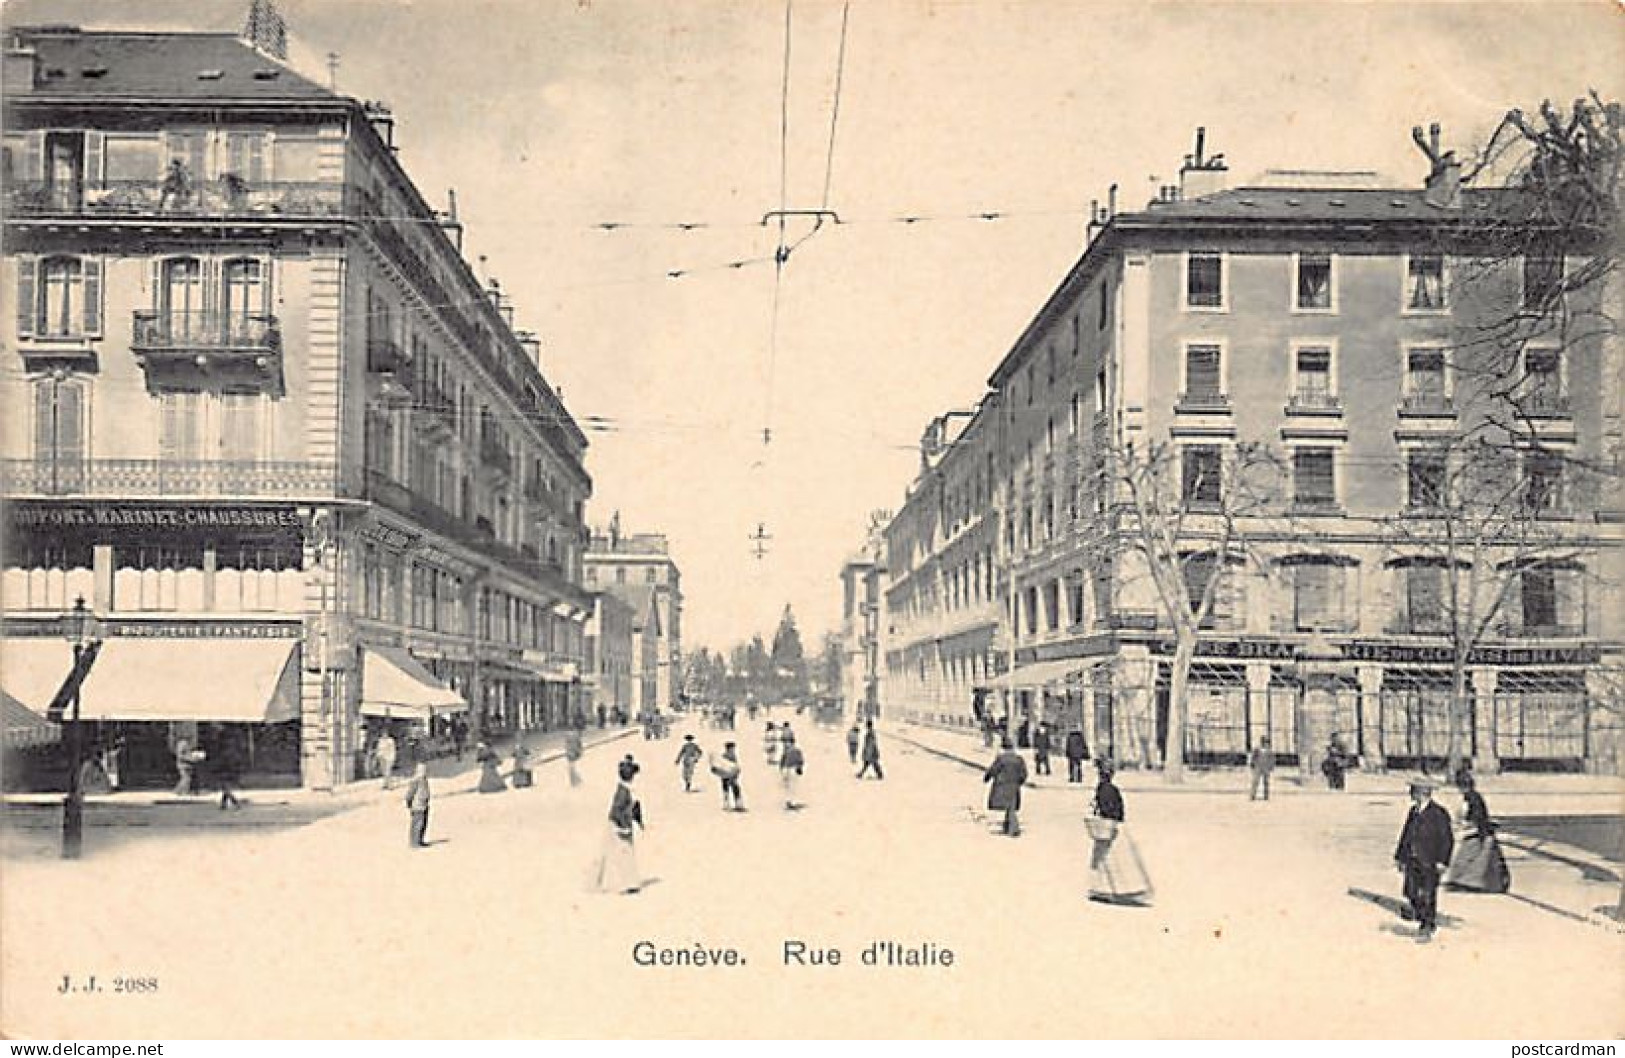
[0,725,640,829]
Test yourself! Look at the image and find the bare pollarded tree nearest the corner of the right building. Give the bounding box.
[1108,442,1281,783]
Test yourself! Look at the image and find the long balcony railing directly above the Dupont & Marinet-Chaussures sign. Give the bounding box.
[0,458,338,499]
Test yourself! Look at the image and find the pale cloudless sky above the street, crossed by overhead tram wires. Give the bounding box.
[5,0,1625,652]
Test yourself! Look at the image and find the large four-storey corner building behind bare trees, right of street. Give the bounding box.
[887,134,1622,769]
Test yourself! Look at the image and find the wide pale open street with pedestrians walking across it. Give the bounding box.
[0,718,1625,1038]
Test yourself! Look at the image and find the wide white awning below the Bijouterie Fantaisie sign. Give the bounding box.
[80,637,299,723]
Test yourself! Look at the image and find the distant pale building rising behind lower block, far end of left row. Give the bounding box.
[583,526,683,712]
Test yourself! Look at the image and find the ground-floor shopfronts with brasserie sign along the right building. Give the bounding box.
[929,637,1625,774]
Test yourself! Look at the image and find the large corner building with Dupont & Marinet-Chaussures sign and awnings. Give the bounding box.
[0,26,592,787]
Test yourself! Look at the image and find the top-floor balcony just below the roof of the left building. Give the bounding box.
[5,177,346,219]
